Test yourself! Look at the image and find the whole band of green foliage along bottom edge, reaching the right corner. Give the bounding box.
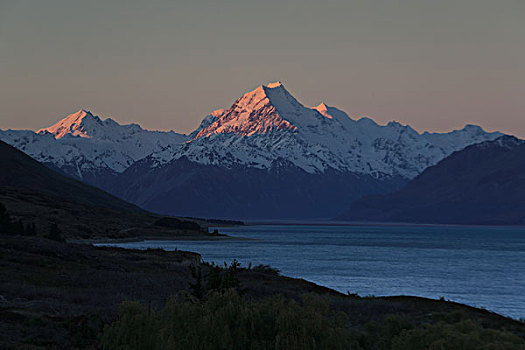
[102,289,525,350]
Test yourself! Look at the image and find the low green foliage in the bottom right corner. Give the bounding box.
[392,320,525,350]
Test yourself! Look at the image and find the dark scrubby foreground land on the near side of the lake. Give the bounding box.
[0,234,525,350]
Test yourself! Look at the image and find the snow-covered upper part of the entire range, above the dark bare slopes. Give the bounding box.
[0,82,502,183]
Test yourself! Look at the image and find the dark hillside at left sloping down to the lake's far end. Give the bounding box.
[0,141,225,240]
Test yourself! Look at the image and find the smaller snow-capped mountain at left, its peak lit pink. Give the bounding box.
[0,110,188,186]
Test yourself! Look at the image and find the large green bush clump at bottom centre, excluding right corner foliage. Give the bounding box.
[102,289,360,350]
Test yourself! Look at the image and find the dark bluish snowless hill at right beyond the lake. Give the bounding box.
[338,136,525,225]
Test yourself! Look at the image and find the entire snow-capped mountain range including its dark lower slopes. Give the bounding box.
[0,82,502,219]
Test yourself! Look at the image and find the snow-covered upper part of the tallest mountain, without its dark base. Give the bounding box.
[146,82,501,179]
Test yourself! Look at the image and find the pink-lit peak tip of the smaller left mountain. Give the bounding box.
[37,109,102,139]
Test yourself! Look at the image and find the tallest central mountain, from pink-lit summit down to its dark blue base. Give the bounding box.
[106,82,500,219]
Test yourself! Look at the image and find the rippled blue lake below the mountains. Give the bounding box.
[98,225,525,318]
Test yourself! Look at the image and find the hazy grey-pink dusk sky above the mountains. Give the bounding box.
[0,0,525,138]
